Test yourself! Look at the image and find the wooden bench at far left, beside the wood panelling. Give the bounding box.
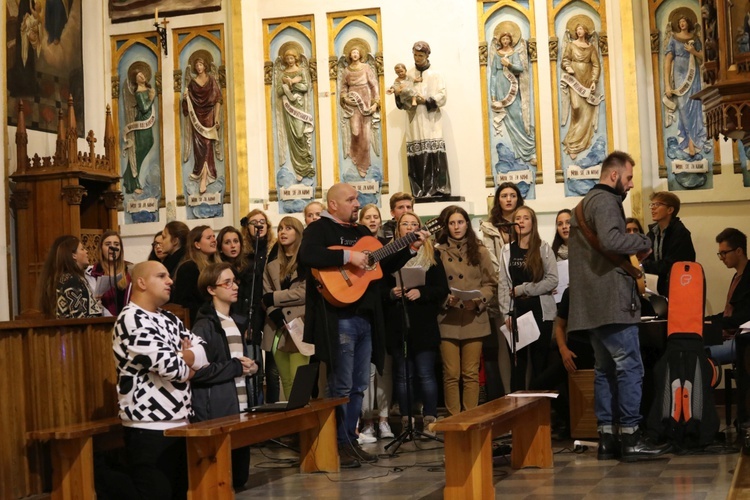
[26,417,123,500]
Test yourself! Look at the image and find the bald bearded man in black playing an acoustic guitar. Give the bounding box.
[299,184,429,468]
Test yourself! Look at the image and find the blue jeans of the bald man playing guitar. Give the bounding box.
[328,316,372,444]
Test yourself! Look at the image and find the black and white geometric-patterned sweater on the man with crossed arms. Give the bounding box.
[112,302,204,429]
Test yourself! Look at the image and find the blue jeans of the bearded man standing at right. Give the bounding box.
[591,324,643,431]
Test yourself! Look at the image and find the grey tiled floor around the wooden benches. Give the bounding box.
[237,432,738,500]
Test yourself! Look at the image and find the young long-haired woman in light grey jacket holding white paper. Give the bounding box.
[498,206,557,391]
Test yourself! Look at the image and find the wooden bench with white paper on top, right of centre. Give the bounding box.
[430,396,553,500]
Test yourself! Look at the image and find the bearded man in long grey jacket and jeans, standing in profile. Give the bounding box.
[568,151,668,461]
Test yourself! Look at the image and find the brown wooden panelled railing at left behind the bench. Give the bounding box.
[0,318,117,499]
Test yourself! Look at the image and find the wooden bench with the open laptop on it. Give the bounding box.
[164,398,349,499]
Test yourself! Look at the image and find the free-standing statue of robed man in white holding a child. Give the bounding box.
[396,41,451,198]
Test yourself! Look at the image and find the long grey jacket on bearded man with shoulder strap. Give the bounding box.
[568,184,651,331]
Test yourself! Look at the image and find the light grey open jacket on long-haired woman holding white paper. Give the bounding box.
[497,241,558,321]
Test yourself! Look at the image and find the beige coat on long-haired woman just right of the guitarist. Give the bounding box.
[437,238,497,340]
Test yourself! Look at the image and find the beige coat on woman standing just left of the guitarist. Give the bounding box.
[261,259,305,352]
